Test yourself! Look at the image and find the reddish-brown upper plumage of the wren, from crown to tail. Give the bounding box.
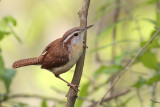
[12,27,81,70]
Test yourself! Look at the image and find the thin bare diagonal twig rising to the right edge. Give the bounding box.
[97,28,160,106]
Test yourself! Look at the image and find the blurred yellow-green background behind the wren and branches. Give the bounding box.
[0,0,160,107]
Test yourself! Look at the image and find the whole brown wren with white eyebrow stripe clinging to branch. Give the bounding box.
[12,25,93,91]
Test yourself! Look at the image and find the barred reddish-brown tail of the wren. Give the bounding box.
[12,56,43,68]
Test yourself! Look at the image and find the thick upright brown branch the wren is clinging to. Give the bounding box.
[66,0,90,107]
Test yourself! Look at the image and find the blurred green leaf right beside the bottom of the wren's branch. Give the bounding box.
[75,82,89,107]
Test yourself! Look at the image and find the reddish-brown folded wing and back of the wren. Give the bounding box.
[41,39,69,69]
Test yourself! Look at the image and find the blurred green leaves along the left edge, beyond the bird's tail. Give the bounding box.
[0,16,19,107]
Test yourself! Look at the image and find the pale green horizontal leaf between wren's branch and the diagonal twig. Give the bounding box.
[94,65,123,77]
